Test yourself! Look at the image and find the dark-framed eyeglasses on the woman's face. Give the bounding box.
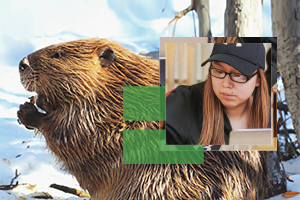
[209,67,258,83]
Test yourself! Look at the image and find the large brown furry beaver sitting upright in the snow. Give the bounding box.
[17,39,269,199]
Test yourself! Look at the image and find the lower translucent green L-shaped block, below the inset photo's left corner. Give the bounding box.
[123,130,204,164]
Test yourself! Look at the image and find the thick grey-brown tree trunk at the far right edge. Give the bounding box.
[271,0,300,146]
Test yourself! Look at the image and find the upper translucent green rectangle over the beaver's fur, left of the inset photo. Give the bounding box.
[123,86,165,121]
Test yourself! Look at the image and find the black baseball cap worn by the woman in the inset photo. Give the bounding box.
[201,43,266,76]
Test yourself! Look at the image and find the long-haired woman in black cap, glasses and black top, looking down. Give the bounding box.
[166,39,270,145]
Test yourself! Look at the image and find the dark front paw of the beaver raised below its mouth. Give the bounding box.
[17,102,46,129]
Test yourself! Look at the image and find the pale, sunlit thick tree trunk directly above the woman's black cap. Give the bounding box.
[224,0,263,37]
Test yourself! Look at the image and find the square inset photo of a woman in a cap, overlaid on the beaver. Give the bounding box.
[160,37,277,151]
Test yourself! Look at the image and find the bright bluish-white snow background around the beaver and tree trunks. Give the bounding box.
[0,0,300,200]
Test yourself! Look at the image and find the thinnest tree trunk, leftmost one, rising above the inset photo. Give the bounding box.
[192,0,211,37]
